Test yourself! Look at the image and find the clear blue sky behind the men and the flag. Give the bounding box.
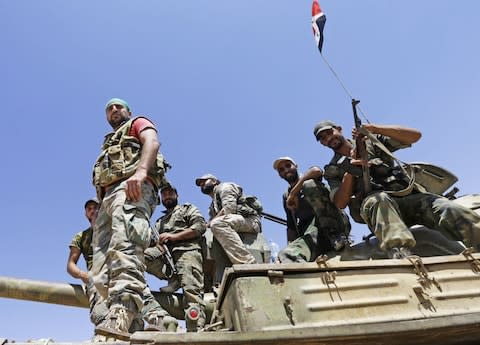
[0,0,480,342]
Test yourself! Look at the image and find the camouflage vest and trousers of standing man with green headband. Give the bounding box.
[90,118,165,329]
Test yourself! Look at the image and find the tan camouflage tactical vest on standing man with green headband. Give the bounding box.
[93,117,170,195]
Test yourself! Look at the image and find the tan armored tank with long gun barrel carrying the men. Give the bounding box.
[0,165,480,345]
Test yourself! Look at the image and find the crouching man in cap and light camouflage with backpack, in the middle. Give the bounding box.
[195,174,261,264]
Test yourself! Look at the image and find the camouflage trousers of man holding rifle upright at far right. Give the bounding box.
[360,192,480,250]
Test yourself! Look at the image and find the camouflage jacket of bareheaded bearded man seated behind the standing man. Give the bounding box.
[155,203,207,251]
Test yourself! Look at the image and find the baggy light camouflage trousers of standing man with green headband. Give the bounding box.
[89,181,158,314]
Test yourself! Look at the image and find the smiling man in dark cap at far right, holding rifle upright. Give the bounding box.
[313,120,480,258]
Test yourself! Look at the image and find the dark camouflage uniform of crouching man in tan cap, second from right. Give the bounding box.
[278,179,351,262]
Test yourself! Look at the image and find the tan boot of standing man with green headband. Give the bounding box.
[95,304,135,341]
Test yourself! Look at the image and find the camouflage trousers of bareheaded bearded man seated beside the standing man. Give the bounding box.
[145,247,205,311]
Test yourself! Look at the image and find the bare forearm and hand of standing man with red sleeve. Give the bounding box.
[125,127,160,201]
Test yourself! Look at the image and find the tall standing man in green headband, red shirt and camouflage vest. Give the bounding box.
[90,98,169,340]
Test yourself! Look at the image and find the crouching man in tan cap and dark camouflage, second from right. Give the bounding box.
[273,157,351,262]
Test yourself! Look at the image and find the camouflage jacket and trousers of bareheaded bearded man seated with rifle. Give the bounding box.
[145,203,206,330]
